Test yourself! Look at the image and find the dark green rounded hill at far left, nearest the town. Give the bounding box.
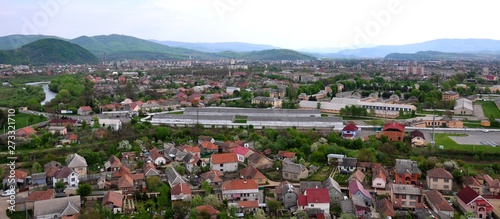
[0,39,98,65]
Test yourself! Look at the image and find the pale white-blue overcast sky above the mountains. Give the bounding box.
[0,0,500,49]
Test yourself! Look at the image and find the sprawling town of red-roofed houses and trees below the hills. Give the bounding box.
[0,56,500,218]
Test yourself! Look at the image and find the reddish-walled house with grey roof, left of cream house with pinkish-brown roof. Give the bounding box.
[394,159,422,185]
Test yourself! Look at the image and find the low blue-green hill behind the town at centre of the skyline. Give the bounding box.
[238,49,316,61]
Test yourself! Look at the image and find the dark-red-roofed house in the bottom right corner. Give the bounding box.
[457,186,493,218]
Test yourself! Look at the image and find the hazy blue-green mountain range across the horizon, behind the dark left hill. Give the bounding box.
[0,34,500,63]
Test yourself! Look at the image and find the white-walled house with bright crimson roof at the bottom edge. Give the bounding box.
[297,188,330,213]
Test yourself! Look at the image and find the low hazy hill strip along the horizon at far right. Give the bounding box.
[385,51,500,61]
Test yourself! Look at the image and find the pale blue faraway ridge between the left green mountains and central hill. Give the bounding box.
[151,40,278,53]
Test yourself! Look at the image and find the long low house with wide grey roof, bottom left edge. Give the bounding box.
[33,195,81,219]
